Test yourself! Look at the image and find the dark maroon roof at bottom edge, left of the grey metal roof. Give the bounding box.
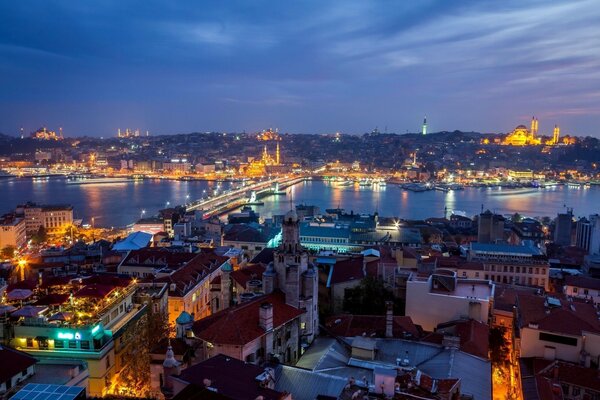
[179,354,287,400]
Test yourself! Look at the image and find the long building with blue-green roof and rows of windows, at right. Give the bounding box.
[467,242,550,290]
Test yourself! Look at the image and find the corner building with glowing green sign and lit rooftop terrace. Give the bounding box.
[2,275,147,396]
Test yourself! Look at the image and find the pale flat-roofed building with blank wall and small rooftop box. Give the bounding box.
[406,270,494,331]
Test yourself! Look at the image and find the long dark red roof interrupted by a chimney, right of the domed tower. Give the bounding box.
[325,314,420,338]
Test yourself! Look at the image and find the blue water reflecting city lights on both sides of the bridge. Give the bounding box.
[0,178,600,227]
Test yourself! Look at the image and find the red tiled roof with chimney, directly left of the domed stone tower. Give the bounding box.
[192,292,304,346]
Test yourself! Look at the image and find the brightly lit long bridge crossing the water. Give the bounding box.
[186,176,306,218]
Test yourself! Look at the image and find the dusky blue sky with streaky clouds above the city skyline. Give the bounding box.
[0,0,600,136]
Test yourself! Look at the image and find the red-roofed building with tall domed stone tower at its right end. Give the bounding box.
[193,210,319,364]
